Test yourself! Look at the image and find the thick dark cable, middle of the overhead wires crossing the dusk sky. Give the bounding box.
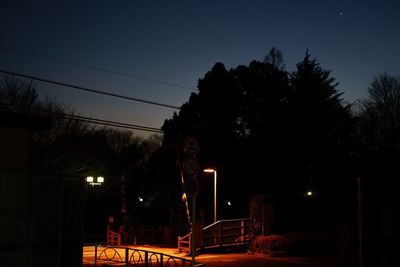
[0,69,180,109]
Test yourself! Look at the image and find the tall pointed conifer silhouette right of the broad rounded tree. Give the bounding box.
[286,51,355,226]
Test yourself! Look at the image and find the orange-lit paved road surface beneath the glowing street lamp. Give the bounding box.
[83,246,338,267]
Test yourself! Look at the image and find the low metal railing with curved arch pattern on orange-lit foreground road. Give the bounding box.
[94,245,192,267]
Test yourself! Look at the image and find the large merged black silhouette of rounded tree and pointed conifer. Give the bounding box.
[163,48,354,222]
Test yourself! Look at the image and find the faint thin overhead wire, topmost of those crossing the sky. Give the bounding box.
[0,47,196,92]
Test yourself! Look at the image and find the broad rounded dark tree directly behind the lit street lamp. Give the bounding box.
[163,50,294,219]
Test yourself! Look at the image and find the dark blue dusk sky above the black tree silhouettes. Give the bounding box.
[0,0,400,136]
